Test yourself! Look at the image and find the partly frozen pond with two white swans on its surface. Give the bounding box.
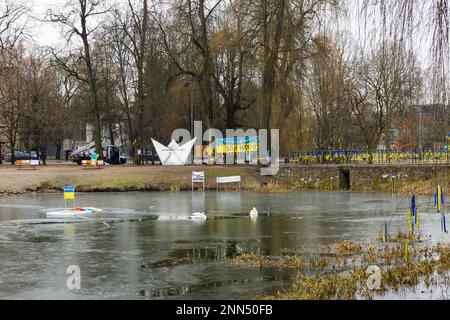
[0,191,444,299]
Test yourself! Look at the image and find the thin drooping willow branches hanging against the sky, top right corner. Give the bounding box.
[358,0,450,103]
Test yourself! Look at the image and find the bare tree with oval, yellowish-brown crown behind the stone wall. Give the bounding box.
[347,44,418,149]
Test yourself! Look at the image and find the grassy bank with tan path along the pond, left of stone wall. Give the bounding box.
[0,165,288,193]
